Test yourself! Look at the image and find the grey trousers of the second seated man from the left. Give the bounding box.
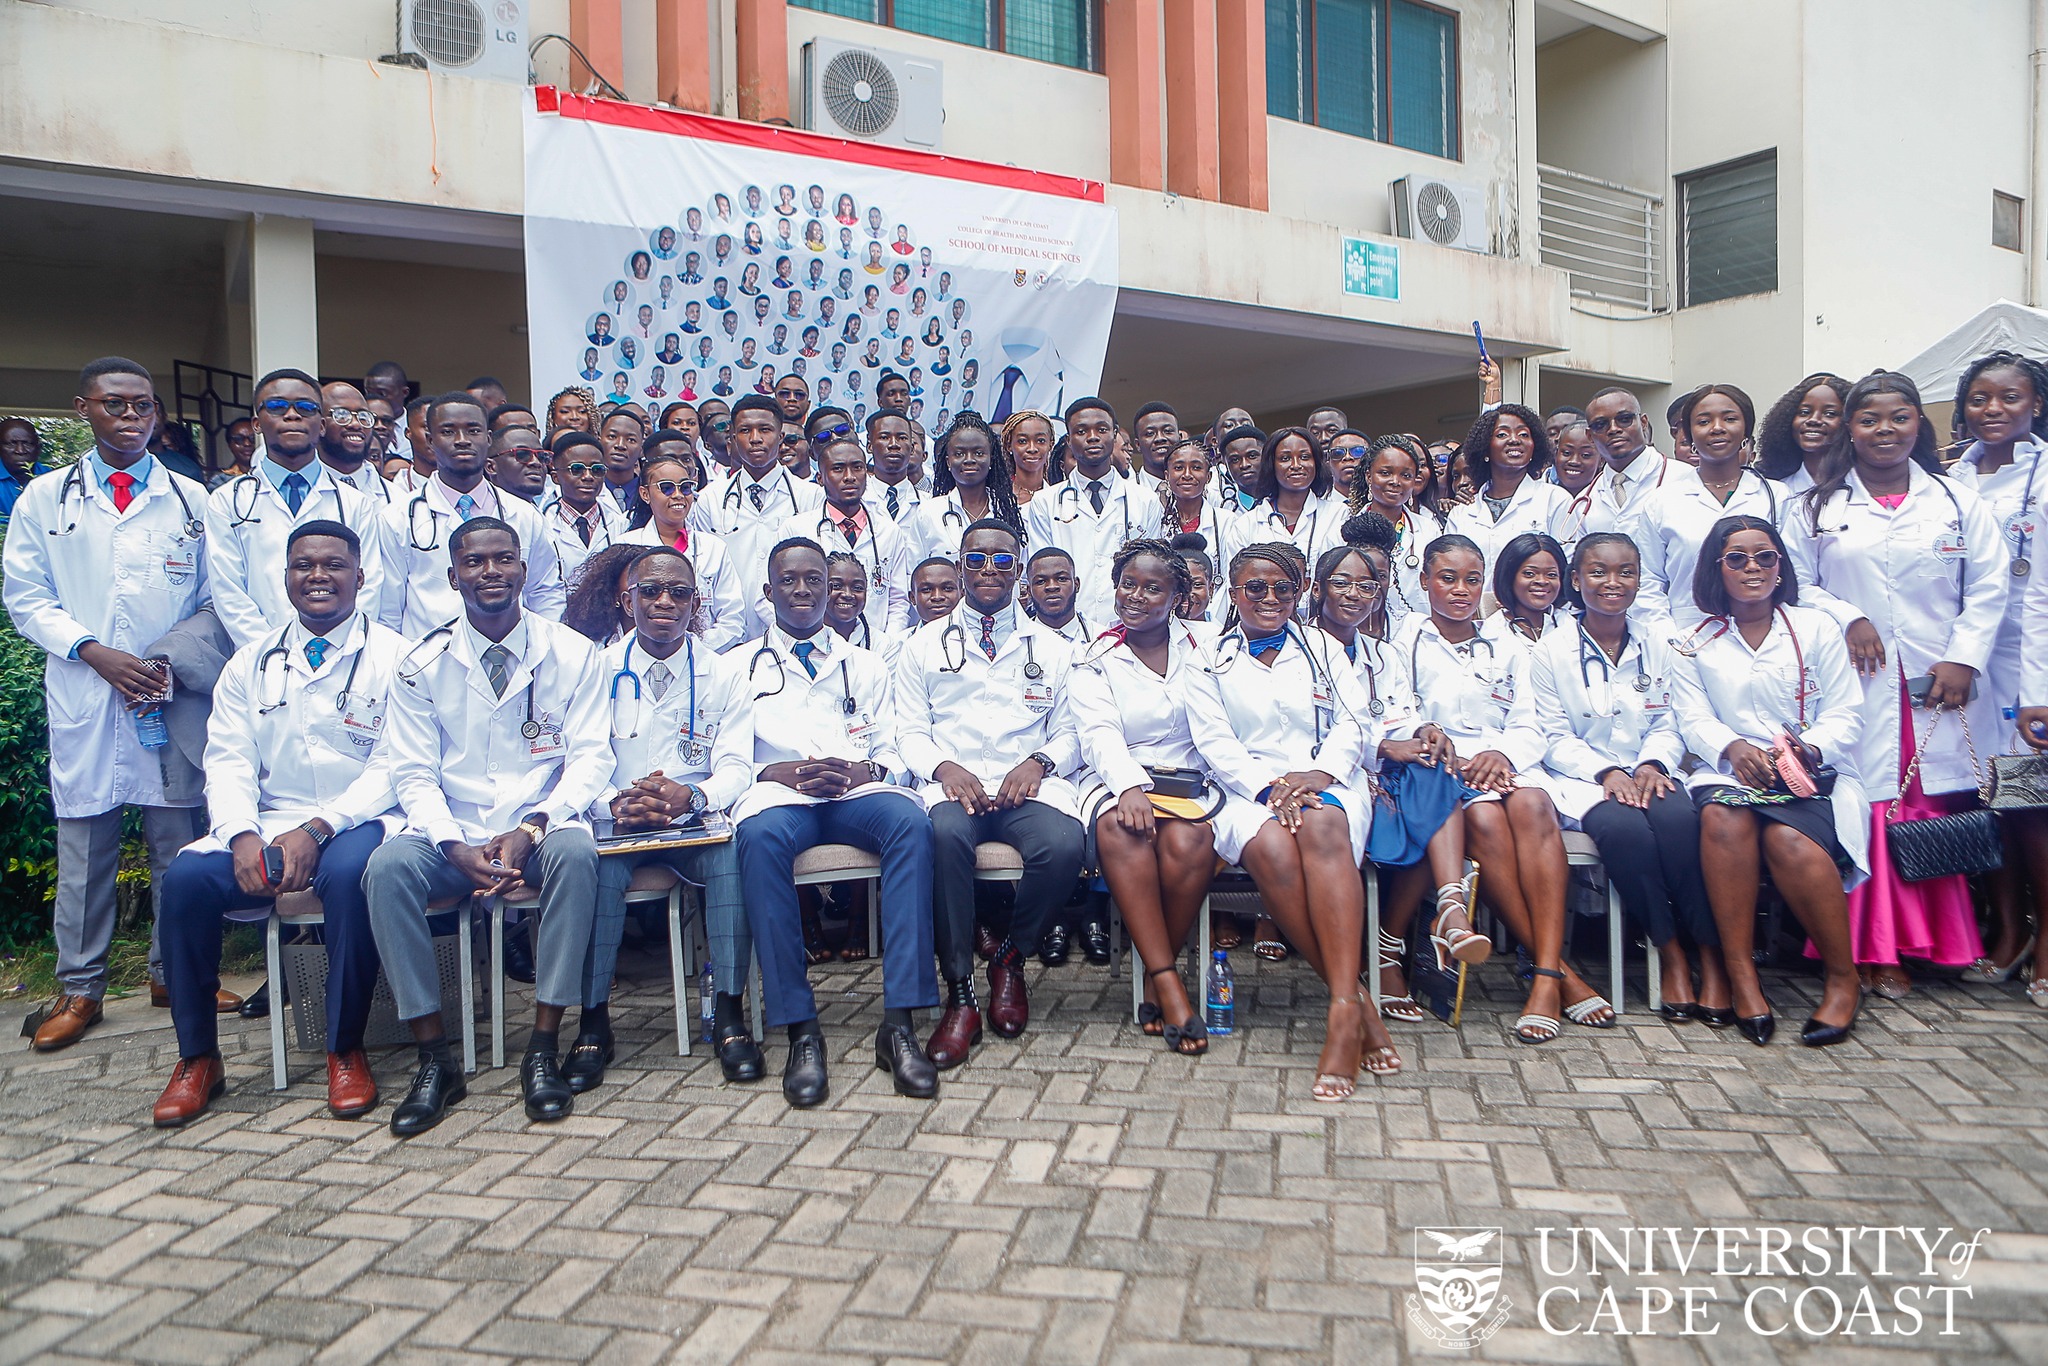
[362,825,598,1020]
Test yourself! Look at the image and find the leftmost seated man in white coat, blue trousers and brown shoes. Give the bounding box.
[154,520,406,1128]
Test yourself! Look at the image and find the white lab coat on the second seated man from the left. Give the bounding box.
[385,612,612,844]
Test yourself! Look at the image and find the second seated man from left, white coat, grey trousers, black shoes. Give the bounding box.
[362,516,612,1139]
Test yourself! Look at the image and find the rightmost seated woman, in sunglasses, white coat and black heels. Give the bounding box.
[1671,516,1870,1047]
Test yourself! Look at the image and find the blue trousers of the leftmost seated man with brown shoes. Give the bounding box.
[158,821,383,1057]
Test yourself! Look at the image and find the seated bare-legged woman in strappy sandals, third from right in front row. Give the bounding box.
[1395,535,1614,1044]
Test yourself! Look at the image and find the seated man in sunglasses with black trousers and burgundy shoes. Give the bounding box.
[897,518,1081,1067]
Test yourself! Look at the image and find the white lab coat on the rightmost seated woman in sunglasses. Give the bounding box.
[1671,606,1867,887]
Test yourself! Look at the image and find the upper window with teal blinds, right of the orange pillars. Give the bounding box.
[1266,0,1458,160]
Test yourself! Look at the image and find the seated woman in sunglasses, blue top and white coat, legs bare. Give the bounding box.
[1188,545,1401,1102]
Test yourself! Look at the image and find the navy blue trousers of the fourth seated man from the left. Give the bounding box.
[733,793,938,1026]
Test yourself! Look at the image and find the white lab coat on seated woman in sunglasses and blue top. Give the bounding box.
[1186,625,1380,862]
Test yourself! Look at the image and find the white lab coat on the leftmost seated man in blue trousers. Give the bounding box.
[190,610,408,852]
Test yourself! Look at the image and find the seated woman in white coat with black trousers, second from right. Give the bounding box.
[1509,530,1735,1028]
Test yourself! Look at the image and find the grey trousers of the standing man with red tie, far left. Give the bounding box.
[51,807,199,999]
